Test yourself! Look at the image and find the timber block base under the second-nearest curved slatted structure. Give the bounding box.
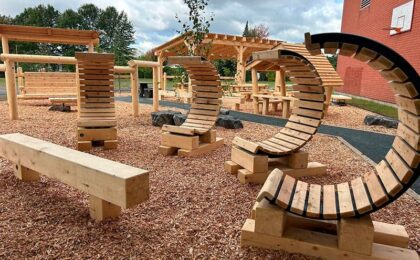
[225,146,327,184]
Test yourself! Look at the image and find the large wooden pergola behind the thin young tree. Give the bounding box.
[154,33,282,88]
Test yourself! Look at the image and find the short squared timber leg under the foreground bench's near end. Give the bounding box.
[89,195,121,221]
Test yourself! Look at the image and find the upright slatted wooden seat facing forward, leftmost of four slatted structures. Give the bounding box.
[76,53,117,151]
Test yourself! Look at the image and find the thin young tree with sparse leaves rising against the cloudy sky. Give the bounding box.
[175,0,214,57]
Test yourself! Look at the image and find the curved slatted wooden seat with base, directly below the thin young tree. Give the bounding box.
[159,56,223,156]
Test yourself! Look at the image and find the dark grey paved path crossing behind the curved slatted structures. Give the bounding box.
[117,97,420,194]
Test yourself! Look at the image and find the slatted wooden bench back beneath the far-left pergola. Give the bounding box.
[18,72,77,99]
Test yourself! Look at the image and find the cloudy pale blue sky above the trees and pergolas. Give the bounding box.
[0,0,343,52]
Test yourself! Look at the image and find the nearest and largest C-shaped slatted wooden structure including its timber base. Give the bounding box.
[241,33,420,259]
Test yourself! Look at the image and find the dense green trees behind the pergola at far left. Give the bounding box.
[0,4,135,70]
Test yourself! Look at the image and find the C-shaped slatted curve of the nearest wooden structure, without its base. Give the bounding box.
[257,33,420,219]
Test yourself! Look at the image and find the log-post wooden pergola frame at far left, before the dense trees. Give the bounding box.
[0,24,99,119]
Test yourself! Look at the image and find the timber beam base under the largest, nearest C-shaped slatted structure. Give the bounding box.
[241,200,418,260]
